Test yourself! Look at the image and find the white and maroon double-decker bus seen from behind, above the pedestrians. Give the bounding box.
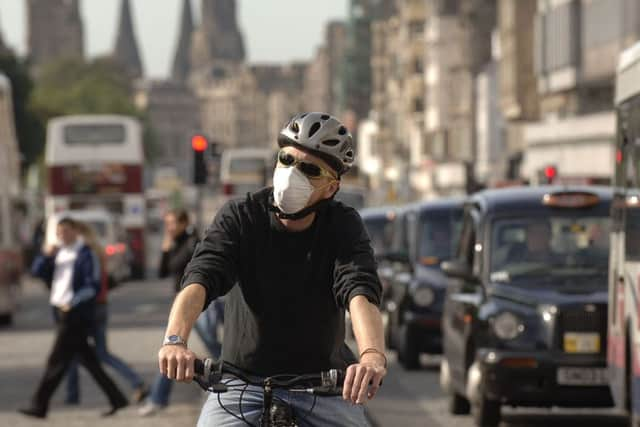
[45,115,145,278]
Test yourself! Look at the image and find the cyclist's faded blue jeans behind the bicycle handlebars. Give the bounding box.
[198,380,369,427]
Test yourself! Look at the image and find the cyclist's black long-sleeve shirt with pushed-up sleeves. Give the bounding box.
[182,189,382,375]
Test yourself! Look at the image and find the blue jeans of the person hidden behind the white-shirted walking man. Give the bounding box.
[67,304,144,402]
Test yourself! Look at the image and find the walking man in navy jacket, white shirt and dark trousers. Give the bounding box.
[19,218,128,418]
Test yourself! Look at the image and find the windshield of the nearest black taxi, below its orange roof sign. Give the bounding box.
[490,216,610,283]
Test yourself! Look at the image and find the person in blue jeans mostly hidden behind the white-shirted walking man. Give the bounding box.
[65,222,149,405]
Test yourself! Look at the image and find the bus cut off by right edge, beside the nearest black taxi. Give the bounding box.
[607,43,640,427]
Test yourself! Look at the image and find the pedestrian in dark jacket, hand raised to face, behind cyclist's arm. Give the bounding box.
[139,210,221,416]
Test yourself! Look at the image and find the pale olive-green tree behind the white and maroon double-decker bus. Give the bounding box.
[33,58,154,158]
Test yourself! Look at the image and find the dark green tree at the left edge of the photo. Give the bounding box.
[0,51,45,172]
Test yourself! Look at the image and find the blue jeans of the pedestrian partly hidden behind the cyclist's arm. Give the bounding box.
[149,300,224,406]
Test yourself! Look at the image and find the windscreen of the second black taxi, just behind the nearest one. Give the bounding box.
[418,209,462,267]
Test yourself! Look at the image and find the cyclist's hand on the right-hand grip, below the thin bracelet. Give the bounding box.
[342,353,387,405]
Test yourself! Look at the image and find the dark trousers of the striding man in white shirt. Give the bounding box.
[32,309,127,413]
